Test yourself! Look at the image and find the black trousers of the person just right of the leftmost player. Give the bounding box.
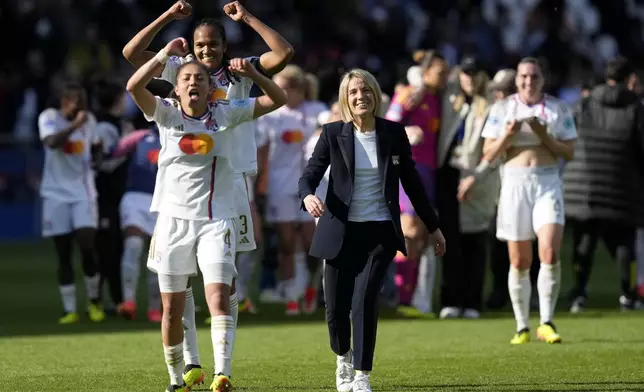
[96,201,123,305]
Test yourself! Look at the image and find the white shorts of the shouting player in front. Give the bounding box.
[147,214,237,292]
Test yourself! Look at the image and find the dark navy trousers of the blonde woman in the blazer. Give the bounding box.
[324,221,397,371]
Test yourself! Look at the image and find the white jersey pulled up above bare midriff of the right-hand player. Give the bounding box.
[481,94,577,146]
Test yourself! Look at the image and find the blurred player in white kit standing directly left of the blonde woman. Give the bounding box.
[257,65,320,315]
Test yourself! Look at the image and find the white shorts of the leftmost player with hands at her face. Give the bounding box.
[42,198,98,237]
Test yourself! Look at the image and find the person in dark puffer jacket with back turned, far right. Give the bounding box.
[564,58,644,313]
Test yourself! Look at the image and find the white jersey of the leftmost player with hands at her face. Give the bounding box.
[38,109,96,203]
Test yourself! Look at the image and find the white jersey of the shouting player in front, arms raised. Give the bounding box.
[146,97,255,220]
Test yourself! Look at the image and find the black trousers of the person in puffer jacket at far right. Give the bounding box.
[569,219,637,299]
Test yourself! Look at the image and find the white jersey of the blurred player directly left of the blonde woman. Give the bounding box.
[257,102,317,195]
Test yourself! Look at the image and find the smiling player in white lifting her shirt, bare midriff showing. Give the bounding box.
[482,58,577,344]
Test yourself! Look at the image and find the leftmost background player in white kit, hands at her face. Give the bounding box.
[38,84,105,324]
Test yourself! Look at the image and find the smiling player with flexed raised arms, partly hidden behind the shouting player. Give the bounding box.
[123,0,293,386]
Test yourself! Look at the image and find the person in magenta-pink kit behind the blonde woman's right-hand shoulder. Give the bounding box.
[386,51,447,313]
